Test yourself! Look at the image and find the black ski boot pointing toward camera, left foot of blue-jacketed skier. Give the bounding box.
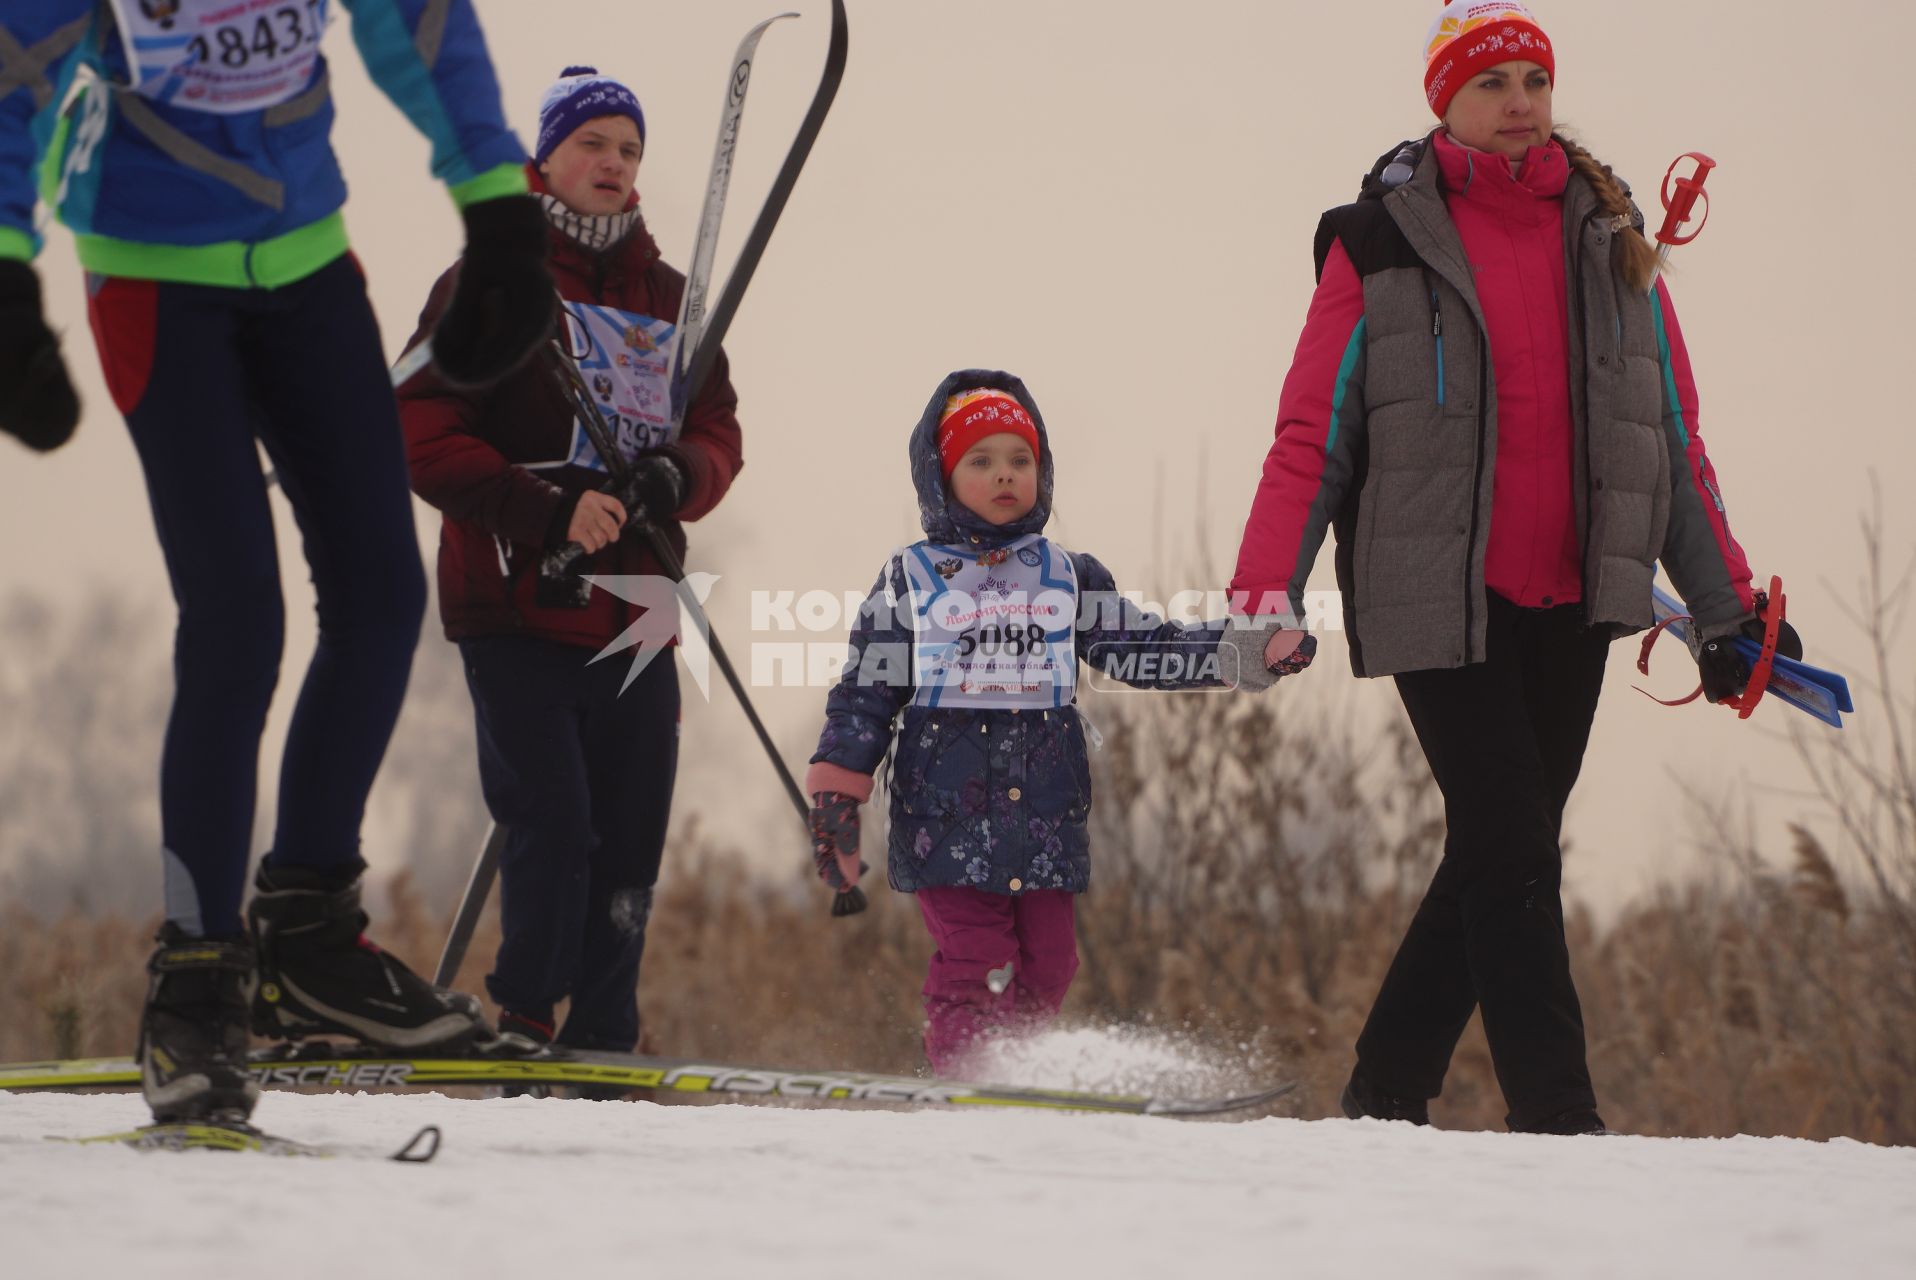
[138,924,259,1125]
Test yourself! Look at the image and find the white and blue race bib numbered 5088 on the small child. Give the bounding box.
[902,533,1077,709]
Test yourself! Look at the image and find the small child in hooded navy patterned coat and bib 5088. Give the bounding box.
[805,370,1314,1075]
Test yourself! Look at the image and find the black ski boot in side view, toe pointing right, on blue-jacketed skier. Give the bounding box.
[247,866,492,1052]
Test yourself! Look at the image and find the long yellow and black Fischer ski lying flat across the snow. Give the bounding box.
[0,1044,1297,1117]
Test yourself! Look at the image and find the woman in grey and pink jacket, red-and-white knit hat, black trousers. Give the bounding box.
[1222,0,1793,1132]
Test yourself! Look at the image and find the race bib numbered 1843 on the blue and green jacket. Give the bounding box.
[113,0,330,115]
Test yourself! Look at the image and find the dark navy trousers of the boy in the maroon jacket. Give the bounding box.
[460,636,678,1052]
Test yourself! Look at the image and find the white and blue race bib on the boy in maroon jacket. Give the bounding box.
[565,301,678,471]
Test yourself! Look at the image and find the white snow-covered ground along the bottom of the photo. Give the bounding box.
[0,1094,1916,1280]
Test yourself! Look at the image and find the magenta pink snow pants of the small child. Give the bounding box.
[914,885,1077,1075]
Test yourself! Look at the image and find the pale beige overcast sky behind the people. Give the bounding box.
[0,0,1916,919]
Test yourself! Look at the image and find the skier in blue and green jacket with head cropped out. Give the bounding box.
[0,0,554,1123]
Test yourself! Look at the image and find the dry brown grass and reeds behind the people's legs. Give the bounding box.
[0,685,1916,1142]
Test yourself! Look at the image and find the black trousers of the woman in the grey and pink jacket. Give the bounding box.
[1357,594,1609,1129]
